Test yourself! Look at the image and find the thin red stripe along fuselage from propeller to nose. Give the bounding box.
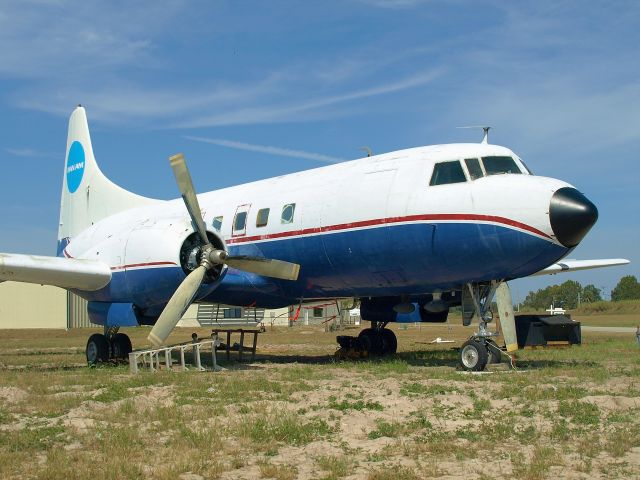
[227,213,551,244]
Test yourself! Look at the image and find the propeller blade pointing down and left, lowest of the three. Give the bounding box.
[147,265,207,347]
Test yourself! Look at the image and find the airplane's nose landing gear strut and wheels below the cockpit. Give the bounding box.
[460,282,503,372]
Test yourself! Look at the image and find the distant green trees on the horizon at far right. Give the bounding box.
[522,275,640,310]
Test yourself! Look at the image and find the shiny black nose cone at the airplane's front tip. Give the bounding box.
[549,187,598,247]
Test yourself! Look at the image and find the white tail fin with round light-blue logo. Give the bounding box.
[58,105,156,251]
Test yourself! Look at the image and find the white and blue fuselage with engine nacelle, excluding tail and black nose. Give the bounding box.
[61,144,573,311]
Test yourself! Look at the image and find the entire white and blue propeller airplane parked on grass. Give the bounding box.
[0,105,629,370]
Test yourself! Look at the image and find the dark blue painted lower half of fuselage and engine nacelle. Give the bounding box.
[76,223,567,308]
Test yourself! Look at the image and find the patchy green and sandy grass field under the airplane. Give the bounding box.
[0,325,640,480]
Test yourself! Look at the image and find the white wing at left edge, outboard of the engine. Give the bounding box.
[0,253,111,292]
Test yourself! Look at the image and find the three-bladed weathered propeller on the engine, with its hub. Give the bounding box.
[148,153,300,346]
